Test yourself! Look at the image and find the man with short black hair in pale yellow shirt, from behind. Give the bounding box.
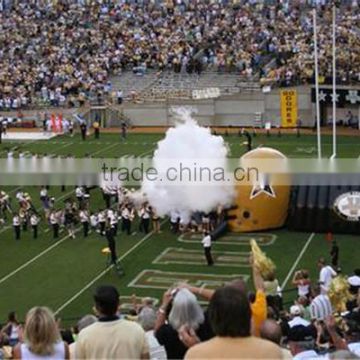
[75,285,149,359]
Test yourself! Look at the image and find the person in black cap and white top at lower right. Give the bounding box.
[288,325,319,360]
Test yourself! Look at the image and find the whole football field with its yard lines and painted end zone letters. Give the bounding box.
[0,133,360,324]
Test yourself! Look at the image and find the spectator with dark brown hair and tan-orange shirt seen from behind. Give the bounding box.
[185,286,282,359]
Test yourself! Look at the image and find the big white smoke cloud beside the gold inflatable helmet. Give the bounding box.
[142,108,234,221]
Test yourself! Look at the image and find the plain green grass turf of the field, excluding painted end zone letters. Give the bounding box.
[0,133,360,324]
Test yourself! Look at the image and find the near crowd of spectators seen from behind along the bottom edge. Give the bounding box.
[0,257,360,359]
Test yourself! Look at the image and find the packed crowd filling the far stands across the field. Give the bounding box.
[0,0,360,110]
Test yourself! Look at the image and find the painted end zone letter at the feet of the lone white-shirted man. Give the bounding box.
[153,247,250,267]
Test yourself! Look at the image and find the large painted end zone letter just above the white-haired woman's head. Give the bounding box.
[128,269,249,289]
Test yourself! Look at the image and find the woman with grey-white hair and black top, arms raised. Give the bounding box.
[155,288,214,359]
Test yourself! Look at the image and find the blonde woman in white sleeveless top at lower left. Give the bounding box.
[13,307,69,360]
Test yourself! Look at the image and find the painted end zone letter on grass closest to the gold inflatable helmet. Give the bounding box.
[178,233,277,246]
